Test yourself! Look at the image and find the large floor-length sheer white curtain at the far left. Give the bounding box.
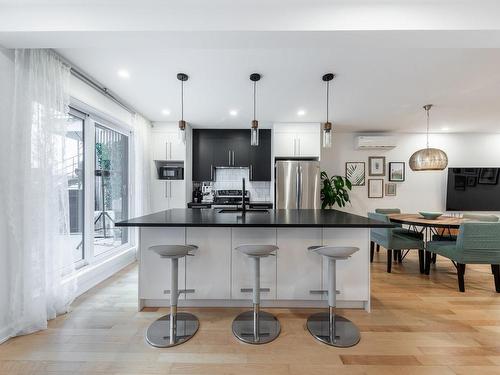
[0,50,76,336]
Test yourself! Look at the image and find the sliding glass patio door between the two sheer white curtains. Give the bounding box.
[64,108,129,268]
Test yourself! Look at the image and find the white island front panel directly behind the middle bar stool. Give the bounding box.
[231,228,276,300]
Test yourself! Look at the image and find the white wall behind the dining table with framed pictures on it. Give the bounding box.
[321,133,500,215]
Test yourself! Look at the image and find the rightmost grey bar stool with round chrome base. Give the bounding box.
[307,246,360,348]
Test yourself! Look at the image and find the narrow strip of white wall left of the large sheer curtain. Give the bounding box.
[0,47,14,342]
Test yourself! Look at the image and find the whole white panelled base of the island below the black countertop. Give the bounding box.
[139,227,370,308]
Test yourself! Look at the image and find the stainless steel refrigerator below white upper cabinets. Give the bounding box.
[275,160,321,209]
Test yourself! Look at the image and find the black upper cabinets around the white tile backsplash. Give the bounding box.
[193,129,271,181]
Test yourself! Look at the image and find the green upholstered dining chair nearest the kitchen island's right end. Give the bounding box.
[368,212,424,273]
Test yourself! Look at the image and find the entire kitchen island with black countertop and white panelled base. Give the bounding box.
[116,209,392,311]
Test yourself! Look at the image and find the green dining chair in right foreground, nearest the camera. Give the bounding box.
[425,222,500,293]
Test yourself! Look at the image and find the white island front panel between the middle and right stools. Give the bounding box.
[277,228,322,300]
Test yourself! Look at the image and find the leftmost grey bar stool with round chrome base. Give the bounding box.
[146,245,200,348]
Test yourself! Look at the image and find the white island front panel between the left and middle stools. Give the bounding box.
[186,227,231,299]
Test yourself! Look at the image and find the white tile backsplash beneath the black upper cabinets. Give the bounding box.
[213,168,271,202]
